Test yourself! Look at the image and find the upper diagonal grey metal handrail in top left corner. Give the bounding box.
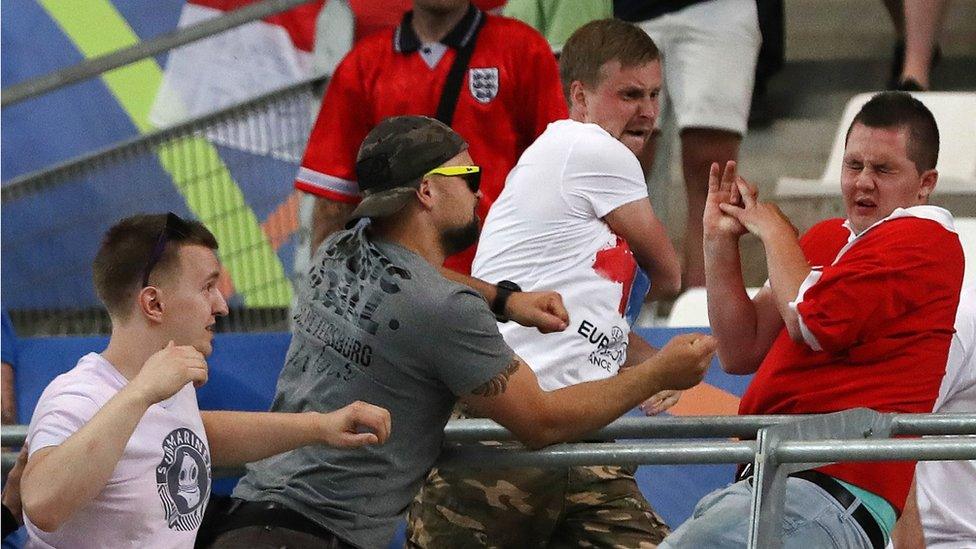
[0,0,312,107]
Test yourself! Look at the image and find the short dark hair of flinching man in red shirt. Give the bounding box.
[844,91,939,173]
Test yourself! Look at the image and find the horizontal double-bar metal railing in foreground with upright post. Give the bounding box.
[2,408,976,549]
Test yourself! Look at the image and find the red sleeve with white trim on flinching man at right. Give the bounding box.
[795,217,958,352]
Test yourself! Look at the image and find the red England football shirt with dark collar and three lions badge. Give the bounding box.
[295,7,568,273]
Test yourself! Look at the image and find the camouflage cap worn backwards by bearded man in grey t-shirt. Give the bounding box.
[352,116,468,219]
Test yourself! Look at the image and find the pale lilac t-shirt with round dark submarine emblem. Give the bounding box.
[25,353,210,549]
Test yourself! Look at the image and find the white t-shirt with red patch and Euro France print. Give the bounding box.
[472,120,647,391]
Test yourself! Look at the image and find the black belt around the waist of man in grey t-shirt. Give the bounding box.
[202,498,355,549]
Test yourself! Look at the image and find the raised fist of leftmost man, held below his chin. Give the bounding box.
[128,341,207,405]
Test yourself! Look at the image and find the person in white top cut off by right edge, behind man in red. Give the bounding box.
[892,286,976,549]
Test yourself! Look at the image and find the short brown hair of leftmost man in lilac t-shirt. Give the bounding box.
[92,214,217,320]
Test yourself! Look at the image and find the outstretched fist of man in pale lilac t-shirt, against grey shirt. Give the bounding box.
[316,400,390,448]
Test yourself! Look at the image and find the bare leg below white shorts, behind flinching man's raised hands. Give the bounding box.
[681,128,742,288]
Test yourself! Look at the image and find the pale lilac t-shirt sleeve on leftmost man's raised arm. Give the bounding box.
[27,390,101,455]
